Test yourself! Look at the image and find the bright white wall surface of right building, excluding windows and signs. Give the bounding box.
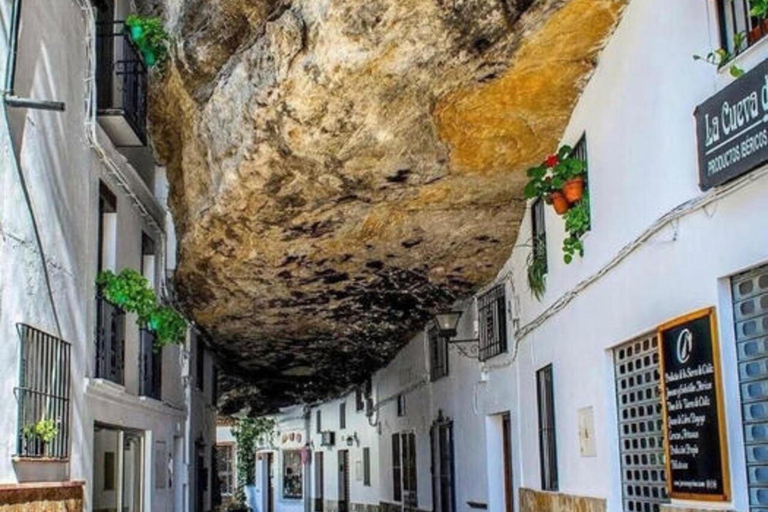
[255,0,768,512]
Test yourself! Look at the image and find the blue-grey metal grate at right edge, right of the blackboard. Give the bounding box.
[731,266,768,512]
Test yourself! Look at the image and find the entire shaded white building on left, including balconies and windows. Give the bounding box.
[0,0,215,512]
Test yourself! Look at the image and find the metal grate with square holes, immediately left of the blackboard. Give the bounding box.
[613,334,669,512]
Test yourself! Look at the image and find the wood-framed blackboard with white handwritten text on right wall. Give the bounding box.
[658,308,730,501]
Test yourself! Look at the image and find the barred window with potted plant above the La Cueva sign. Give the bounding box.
[717,0,768,55]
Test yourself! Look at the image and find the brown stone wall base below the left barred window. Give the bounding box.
[0,482,84,512]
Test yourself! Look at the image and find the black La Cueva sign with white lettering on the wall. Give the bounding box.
[694,55,768,190]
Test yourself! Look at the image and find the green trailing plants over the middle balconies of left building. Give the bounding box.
[96,268,187,348]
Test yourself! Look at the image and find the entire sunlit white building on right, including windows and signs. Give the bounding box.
[255,0,768,512]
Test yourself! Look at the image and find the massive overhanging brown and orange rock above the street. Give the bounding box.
[151,0,624,409]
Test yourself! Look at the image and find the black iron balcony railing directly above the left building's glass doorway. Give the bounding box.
[96,297,125,384]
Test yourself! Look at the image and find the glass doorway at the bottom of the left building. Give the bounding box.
[93,425,144,512]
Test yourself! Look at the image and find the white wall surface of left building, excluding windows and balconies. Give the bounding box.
[0,0,215,512]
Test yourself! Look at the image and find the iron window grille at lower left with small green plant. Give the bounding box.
[14,324,71,459]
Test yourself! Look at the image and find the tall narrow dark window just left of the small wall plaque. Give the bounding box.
[536,365,558,491]
